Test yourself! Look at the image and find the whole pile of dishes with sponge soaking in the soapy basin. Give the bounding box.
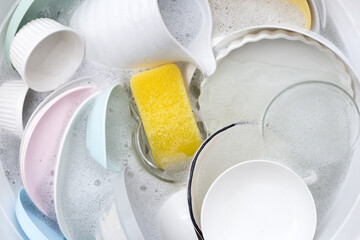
[0,0,360,240]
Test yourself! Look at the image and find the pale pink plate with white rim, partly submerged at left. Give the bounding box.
[20,86,94,217]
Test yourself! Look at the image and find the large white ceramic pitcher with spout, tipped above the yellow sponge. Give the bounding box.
[70,0,216,76]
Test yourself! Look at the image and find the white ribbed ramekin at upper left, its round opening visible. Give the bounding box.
[10,18,85,92]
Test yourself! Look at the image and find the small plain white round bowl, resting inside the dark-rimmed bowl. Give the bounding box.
[201,160,317,240]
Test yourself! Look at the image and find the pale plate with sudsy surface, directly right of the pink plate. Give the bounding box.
[54,91,122,239]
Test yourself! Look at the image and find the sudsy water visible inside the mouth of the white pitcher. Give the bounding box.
[158,0,202,47]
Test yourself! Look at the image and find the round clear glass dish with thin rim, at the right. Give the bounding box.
[263,82,360,165]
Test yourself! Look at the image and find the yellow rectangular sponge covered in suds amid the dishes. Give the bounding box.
[130,64,202,168]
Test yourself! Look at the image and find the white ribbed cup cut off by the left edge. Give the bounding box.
[0,80,29,137]
